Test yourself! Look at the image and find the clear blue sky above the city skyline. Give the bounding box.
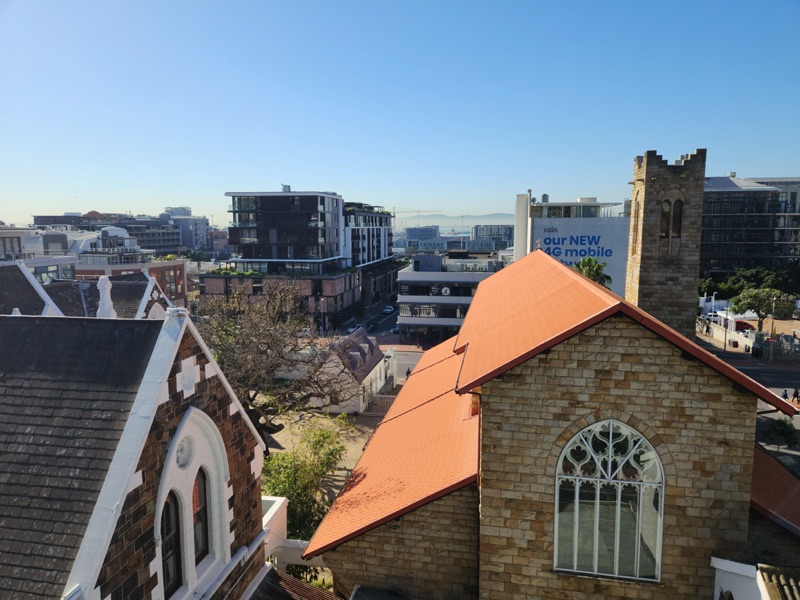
[0,0,800,225]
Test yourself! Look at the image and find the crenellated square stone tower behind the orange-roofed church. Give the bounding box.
[625,148,706,339]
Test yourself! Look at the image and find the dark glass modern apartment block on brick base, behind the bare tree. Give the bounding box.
[200,186,397,330]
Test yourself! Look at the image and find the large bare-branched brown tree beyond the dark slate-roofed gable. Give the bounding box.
[198,278,374,440]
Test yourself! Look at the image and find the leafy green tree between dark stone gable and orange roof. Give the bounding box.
[262,415,348,580]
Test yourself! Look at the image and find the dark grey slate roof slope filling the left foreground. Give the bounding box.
[0,316,162,598]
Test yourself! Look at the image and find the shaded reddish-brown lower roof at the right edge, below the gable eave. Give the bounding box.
[750,444,800,535]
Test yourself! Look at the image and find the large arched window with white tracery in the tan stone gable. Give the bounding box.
[555,420,664,580]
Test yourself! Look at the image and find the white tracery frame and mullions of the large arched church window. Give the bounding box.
[553,419,665,581]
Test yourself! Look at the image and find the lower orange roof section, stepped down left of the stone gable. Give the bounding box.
[304,340,478,558]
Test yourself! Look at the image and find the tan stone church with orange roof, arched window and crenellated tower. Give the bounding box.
[305,151,800,600]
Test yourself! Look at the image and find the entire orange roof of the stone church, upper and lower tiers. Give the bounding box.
[304,251,800,558]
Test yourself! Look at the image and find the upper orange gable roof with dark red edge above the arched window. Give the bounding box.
[453,250,797,415]
